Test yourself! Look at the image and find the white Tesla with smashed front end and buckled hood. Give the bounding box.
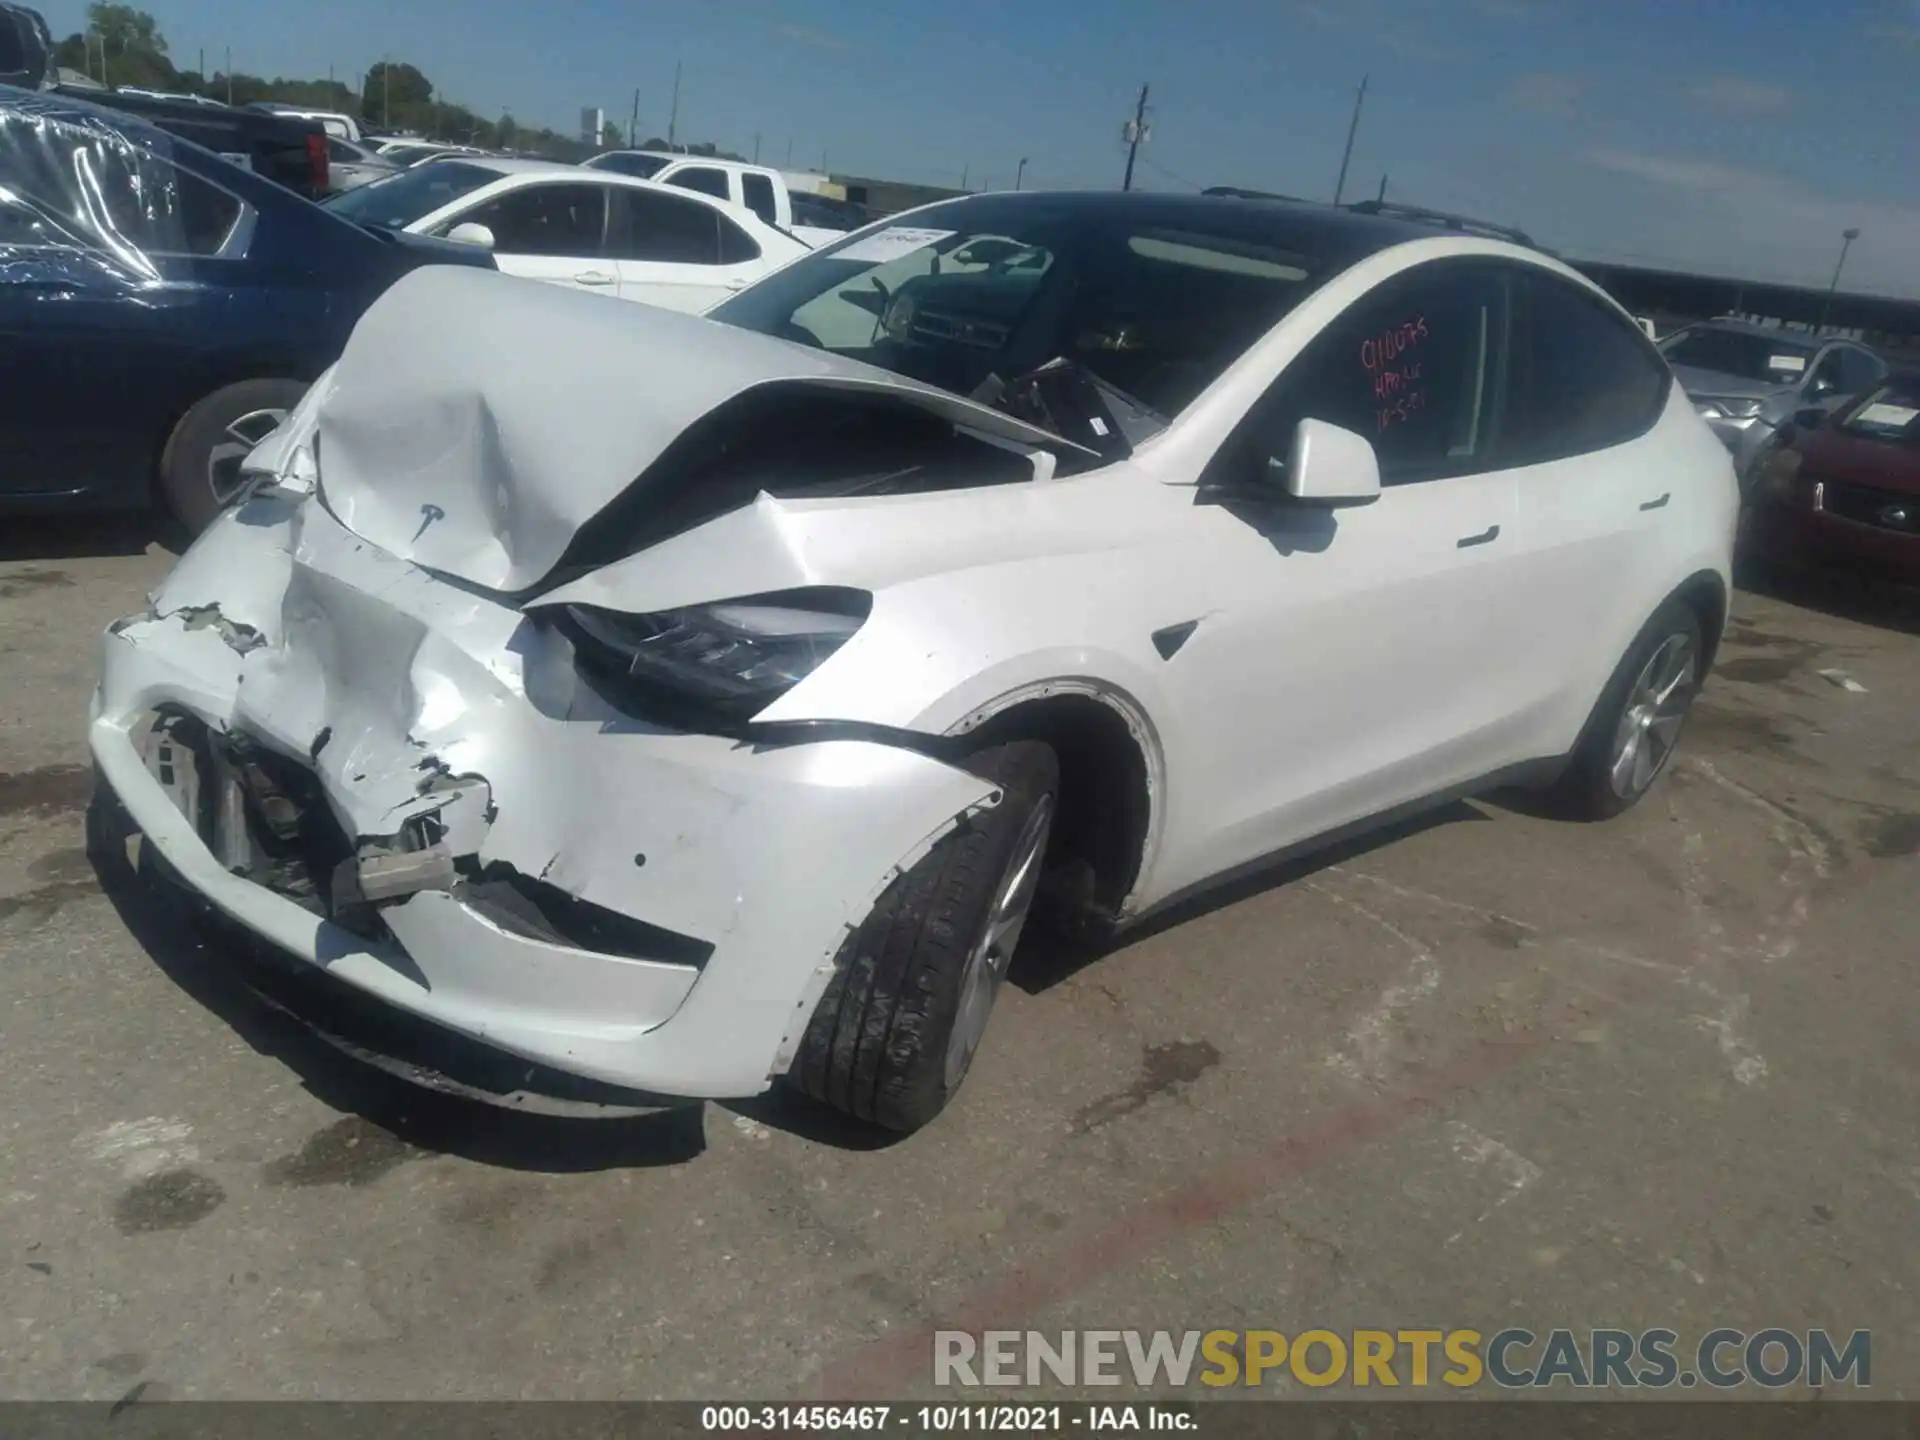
[90,194,1738,1129]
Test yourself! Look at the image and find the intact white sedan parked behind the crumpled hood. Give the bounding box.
[326,156,808,311]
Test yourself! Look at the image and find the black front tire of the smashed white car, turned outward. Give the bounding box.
[787,741,1060,1131]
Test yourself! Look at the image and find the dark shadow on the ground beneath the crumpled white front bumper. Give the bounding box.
[92,814,707,1175]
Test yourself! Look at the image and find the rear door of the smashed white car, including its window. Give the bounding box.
[1501,265,1695,756]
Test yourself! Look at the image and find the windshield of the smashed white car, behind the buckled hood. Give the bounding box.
[707,196,1336,426]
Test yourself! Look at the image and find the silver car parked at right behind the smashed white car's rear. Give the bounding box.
[1659,321,1887,488]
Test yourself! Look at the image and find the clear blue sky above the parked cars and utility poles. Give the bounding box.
[42,0,1920,298]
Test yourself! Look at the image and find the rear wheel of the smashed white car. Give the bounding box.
[1551,601,1703,820]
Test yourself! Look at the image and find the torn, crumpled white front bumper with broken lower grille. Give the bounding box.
[90,492,996,1098]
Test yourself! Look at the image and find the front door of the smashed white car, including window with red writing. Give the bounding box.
[1179,259,1528,876]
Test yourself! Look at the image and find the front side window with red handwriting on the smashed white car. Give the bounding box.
[1242,259,1509,486]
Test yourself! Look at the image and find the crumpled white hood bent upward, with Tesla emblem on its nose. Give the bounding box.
[315,265,1089,591]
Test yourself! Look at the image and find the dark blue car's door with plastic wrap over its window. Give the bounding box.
[0,127,253,505]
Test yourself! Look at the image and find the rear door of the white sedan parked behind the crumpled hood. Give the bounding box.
[609,186,770,313]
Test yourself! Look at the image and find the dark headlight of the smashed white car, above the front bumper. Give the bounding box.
[561,589,872,714]
